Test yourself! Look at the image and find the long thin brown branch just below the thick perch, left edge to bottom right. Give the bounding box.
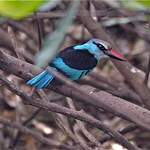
[0,75,138,150]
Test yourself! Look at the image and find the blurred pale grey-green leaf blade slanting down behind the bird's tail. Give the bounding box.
[35,0,80,67]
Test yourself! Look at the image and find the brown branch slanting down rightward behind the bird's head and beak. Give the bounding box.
[78,2,150,108]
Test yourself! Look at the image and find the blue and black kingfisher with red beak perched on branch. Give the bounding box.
[26,38,126,89]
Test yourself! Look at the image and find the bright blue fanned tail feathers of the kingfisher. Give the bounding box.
[26,71,54,89]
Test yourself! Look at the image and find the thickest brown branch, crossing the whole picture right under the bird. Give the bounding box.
[0,51,150,130]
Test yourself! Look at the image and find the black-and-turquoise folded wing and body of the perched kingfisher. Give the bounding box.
[50,47,97,80]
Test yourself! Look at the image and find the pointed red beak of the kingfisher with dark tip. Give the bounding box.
[108,49,127,61]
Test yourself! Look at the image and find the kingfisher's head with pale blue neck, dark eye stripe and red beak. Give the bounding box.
[74,39,126,61]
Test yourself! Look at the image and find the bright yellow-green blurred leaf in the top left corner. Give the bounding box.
[0,0,44,19]
